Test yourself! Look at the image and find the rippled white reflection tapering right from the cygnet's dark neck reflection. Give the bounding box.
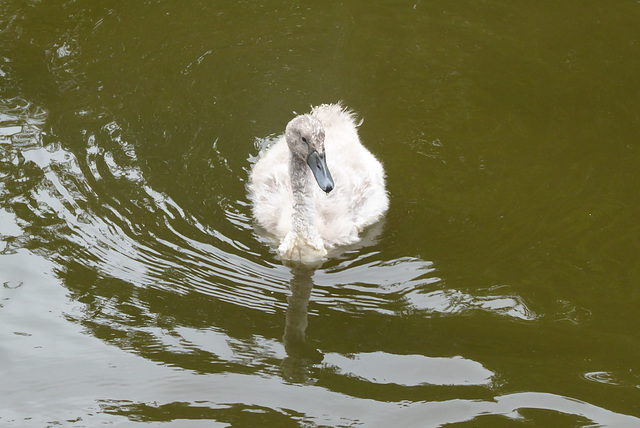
[314,258,537,320]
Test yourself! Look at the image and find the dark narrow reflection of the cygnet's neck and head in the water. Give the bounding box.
[282,264,323,382]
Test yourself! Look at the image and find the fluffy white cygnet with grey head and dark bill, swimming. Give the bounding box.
[248,104,389,262]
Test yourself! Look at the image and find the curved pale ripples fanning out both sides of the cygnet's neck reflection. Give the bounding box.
[1,123,535,320]
